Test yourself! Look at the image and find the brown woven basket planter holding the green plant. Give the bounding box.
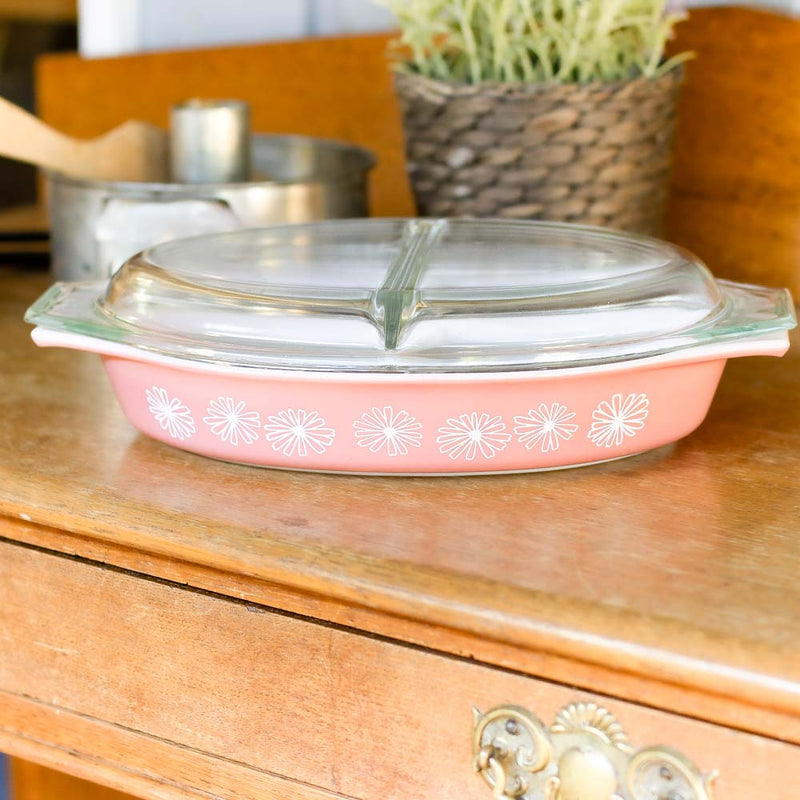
[395,69,683,235]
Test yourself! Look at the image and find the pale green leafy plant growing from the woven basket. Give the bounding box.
[376,0,690,83]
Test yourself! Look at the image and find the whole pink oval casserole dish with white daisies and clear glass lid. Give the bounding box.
[26,219,795,475]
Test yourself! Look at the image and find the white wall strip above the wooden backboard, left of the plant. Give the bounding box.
[78,0,392,58]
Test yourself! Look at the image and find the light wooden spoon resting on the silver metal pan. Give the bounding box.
[0,97,169,181]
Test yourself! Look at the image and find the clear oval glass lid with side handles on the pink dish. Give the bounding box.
[29,219,794,372]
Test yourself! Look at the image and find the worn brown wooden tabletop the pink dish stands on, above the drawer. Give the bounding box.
[0,274,800,742]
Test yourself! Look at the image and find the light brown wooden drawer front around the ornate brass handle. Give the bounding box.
[0,543,800,800]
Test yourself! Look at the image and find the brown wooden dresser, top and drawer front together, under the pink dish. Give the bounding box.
[0,272,800,800]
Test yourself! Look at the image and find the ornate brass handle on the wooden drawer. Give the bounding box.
[472,703,716,800]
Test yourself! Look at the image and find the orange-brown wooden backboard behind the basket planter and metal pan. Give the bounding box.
[37,8,800,296]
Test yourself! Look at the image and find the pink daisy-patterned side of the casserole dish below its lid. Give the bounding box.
[98,355,726,475]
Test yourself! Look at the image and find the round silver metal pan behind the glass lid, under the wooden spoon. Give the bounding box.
[47,134,375,280]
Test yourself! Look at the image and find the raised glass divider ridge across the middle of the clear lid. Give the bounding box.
[373,219,448,350]
